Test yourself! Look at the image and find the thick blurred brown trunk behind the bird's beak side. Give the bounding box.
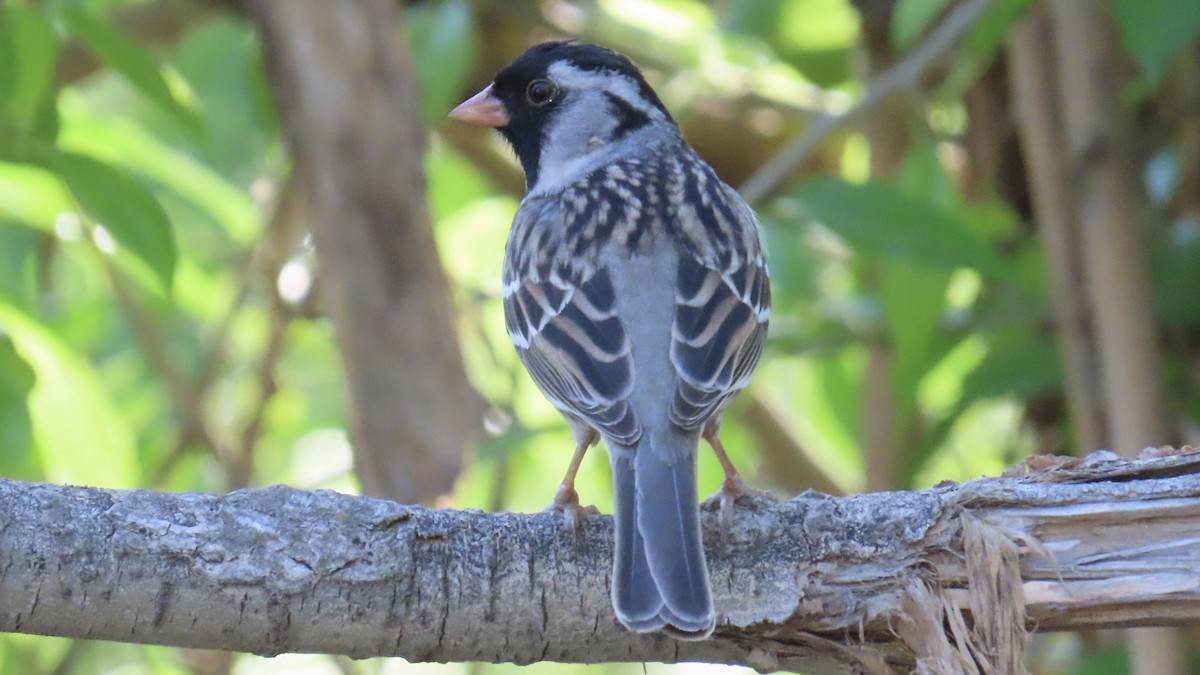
[248,0,482,502]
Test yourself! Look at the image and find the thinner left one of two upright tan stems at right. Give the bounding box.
[1008,5,1106,454]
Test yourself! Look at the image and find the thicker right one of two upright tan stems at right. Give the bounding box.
[1049,0,1184,675]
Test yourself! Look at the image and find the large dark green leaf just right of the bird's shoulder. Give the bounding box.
[792,179,1008,277]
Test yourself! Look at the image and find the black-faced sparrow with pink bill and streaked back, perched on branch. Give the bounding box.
[449,41,770,640]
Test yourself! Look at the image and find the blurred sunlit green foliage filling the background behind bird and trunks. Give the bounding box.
[0,0,1200,675]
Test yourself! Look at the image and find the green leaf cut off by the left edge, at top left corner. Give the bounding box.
[0,6,59,130]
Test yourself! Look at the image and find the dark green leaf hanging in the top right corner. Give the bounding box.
[1111,0,1200,86]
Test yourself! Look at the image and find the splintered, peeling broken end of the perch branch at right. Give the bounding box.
[895,447,1200,674]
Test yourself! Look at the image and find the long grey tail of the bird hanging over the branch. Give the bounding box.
[608,435,716,640]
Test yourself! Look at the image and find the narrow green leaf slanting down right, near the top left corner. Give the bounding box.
[62,7,203,136]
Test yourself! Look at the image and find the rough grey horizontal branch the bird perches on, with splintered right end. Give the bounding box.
[0,448,1200,673]
